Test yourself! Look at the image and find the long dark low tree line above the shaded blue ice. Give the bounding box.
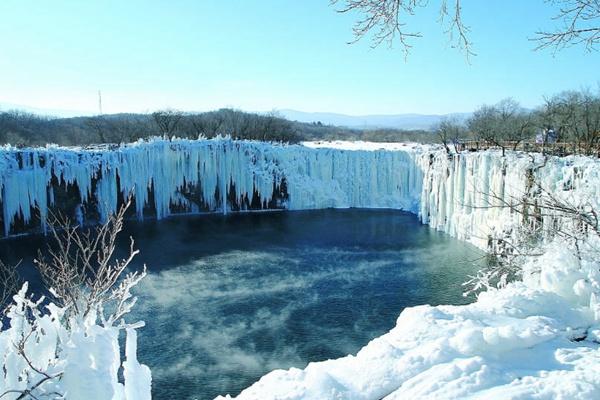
[0,109,435,146]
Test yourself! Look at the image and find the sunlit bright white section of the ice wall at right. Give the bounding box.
[417,151,600,249]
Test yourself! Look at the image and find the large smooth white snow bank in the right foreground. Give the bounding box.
[219,236,600,400]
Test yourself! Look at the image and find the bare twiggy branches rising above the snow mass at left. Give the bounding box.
[34,203,146,325]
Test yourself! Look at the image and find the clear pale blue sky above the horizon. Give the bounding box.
[0,0,600,115]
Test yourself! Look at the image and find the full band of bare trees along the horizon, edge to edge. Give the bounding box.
[0,89,600,154]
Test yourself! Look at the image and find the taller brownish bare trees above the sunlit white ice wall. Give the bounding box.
[435,89,600,155]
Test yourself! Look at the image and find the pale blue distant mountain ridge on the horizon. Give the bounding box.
[277,109,471,130]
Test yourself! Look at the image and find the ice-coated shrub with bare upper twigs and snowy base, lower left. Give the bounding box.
[0,203,151,400]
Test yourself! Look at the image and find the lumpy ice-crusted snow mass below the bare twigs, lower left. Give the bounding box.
[0,284,151,400]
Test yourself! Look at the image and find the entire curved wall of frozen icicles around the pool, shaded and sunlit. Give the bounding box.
[0,138,600,244]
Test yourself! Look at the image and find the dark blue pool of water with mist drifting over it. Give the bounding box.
[0,209,483,399]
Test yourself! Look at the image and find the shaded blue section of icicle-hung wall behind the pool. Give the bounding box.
[0,138,422,234]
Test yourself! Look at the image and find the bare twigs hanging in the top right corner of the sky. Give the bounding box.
[533,0,600,51]
